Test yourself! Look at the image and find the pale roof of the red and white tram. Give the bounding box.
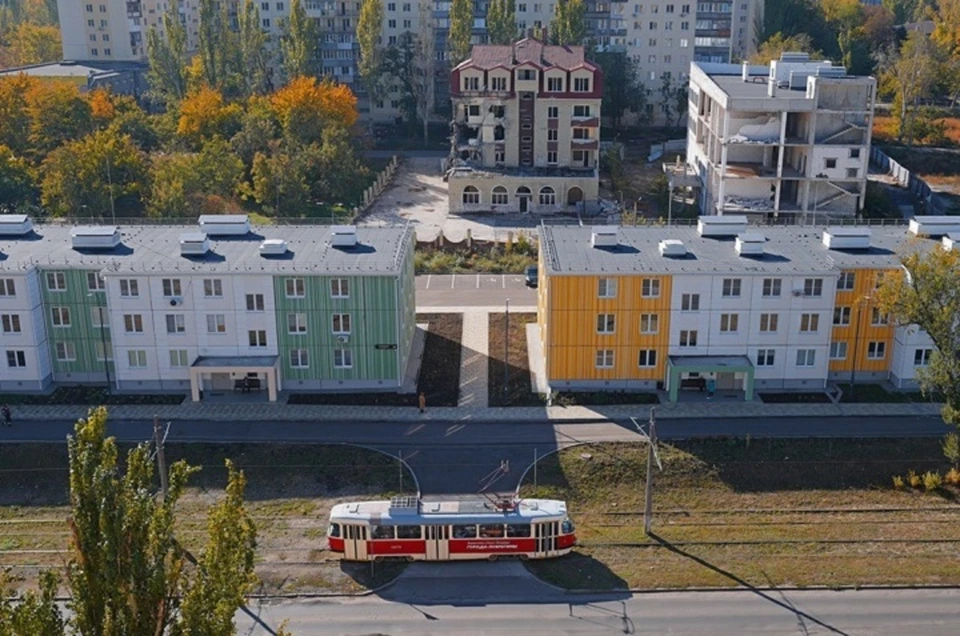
[330,499,567,525]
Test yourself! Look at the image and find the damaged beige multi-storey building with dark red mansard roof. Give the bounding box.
[446,33,603,214]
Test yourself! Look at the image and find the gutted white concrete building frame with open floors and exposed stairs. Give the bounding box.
[687,53,876,219]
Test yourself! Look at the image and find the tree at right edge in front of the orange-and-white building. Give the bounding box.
[876,246,960,431]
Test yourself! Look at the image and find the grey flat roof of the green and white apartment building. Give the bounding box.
[0,224,414,275]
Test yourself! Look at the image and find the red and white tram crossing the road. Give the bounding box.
[327,497,577,561]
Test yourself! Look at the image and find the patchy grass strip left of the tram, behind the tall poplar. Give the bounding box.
[0,444,414,593]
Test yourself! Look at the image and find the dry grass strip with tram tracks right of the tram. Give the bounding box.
[522,439,960,588]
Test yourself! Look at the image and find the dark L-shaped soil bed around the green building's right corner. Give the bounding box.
[288,314,463,408]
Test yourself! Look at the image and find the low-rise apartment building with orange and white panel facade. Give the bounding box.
[538,215,948,400]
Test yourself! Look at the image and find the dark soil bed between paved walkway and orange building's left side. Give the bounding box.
[487,313,544,406]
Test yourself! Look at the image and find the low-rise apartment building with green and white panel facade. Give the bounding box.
[0,215,416,400]
